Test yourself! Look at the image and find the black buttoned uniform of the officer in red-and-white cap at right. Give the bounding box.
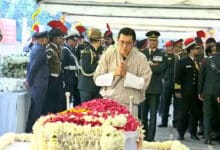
[175,56,201,138]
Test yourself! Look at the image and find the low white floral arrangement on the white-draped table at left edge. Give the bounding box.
[0,78,25,92]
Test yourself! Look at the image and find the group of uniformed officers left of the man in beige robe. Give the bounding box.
[25,23,114,132]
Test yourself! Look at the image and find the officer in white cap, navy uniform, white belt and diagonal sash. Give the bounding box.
[61,32,80,106]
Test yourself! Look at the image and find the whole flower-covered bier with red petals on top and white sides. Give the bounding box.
[32,99,140,150]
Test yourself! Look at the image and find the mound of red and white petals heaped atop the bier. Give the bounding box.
[46,99,140,131]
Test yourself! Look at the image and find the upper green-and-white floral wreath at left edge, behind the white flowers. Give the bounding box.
[0,53,29,78]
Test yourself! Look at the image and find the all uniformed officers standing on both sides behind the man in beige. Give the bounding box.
[25,22,220,144]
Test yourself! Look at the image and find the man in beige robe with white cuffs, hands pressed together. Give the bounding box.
[93,28,152,116]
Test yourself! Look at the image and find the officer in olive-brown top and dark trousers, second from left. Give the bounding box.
[45,28,65,114]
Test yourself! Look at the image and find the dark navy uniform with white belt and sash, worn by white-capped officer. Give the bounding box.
[61,44,81,106]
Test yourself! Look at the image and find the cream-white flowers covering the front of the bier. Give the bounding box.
[31,115,126,150]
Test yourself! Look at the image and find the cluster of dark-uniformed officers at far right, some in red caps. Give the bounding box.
[155,31,220,144]
